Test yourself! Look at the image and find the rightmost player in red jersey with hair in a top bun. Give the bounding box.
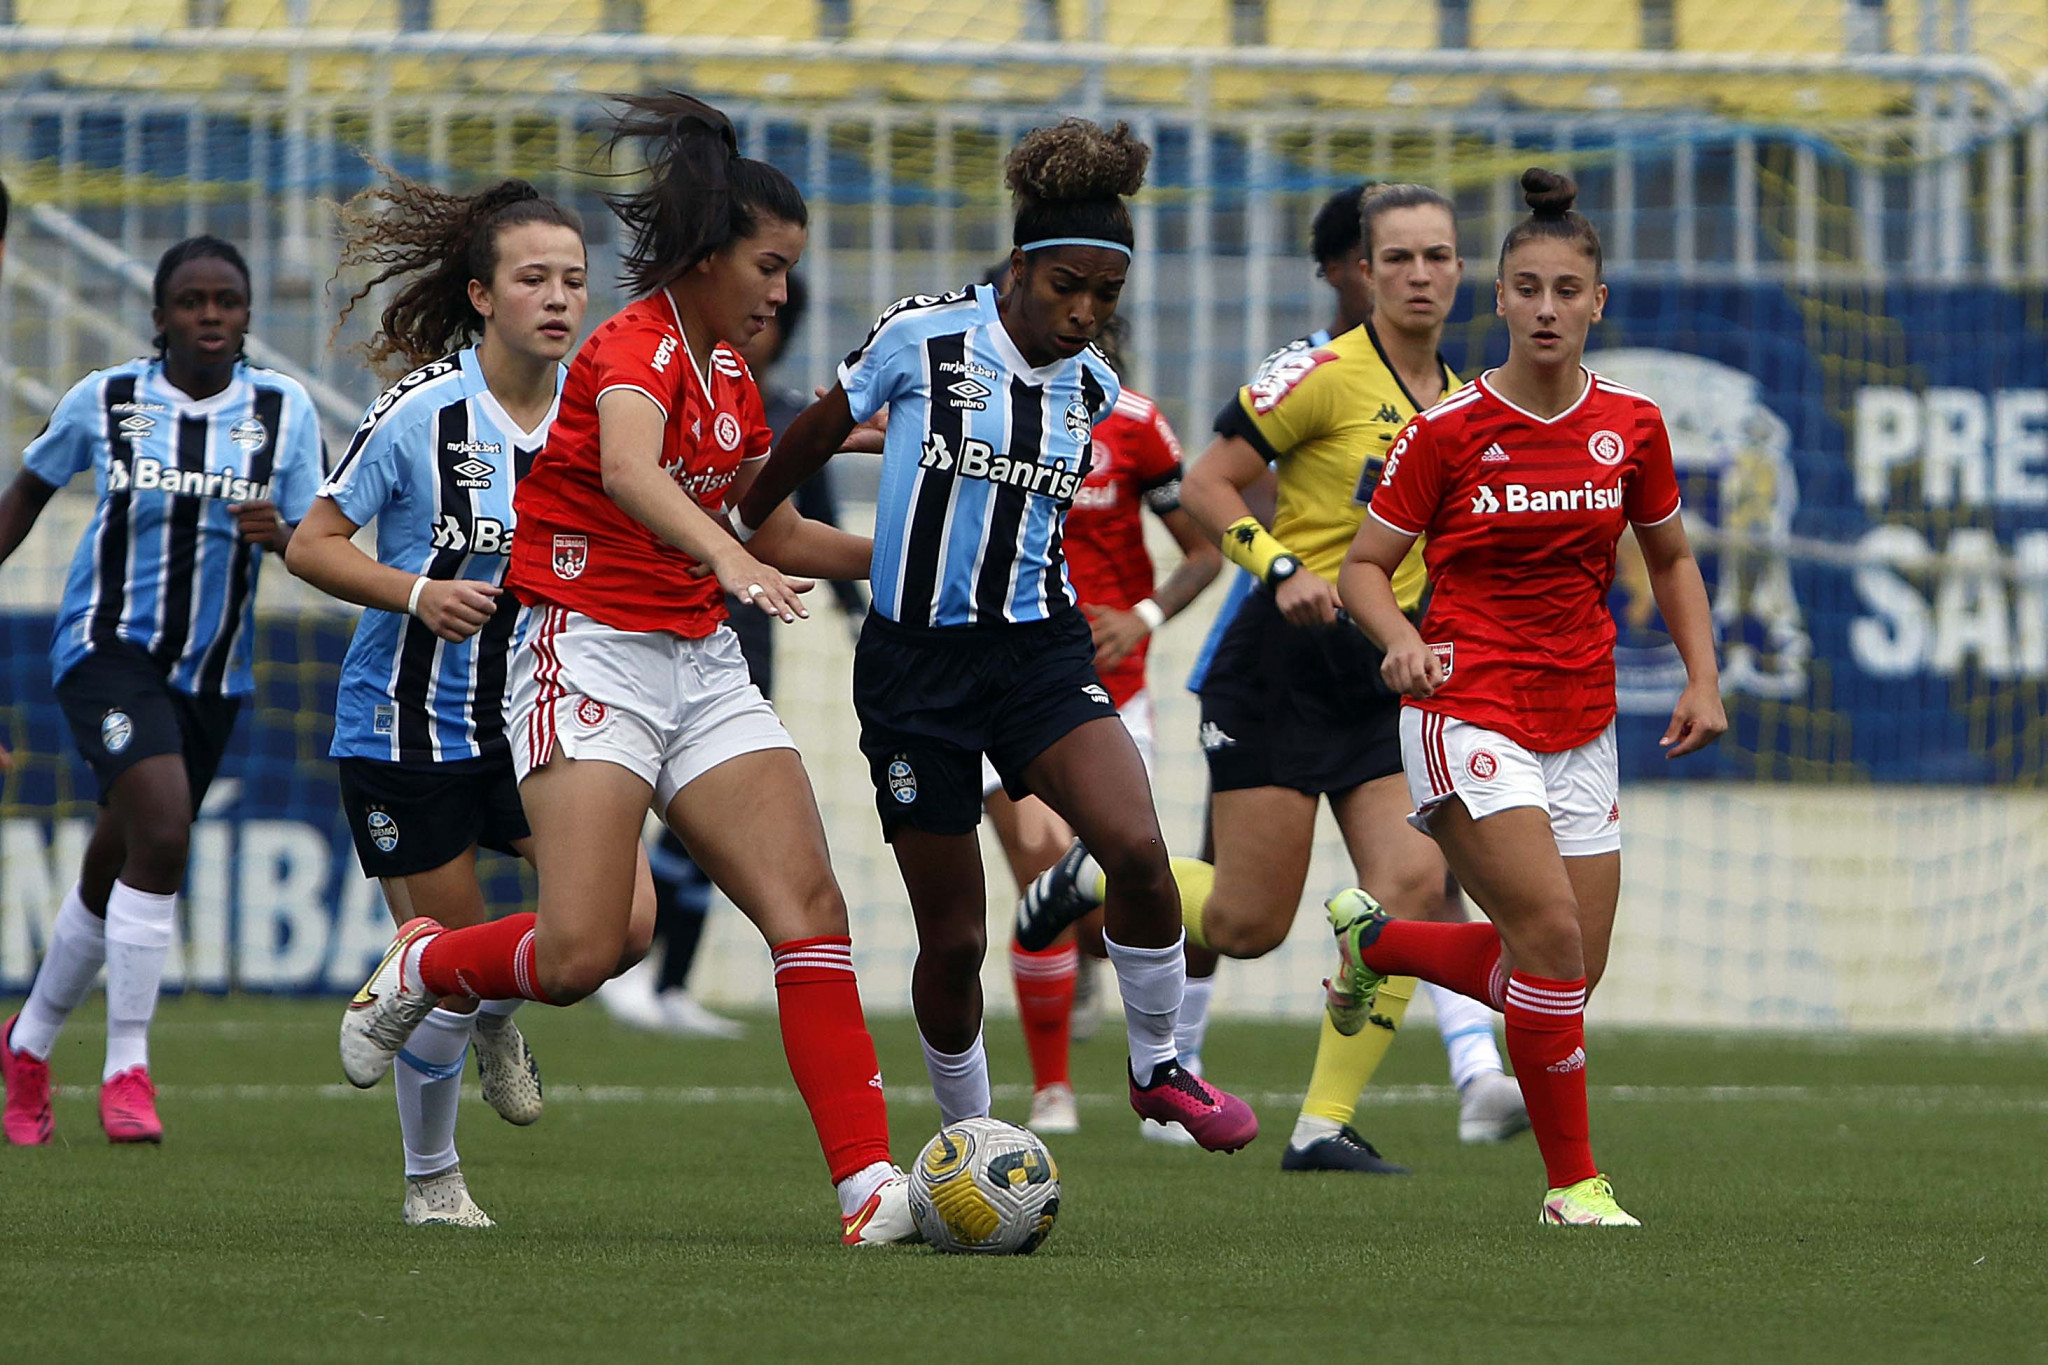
[1329,168,1729,1228]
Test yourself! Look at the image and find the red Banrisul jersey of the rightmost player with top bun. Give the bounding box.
[1368,370,1679,753]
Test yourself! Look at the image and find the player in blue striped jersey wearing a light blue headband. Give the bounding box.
[737,119,1257,1150]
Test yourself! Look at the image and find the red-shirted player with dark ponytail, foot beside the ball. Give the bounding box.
[342,94,915,1244]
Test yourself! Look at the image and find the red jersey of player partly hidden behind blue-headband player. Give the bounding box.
[1061,389,1180,706]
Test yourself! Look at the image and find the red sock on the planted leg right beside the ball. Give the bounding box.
[772,933,889,1185]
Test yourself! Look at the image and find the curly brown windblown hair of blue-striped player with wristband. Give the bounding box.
[334,158,584,379]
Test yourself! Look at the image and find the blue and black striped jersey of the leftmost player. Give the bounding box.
[20,356,324,696]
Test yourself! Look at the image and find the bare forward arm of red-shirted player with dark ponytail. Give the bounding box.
[598,389,813,620]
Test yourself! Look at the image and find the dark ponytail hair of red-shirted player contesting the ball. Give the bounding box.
[604,90,811,295]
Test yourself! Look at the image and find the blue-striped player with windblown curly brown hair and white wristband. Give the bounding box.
[289,172,653,1228]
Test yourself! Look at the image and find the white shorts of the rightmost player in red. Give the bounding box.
[1401,706,1622,857]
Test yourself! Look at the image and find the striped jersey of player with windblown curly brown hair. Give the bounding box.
[319,346,561,763]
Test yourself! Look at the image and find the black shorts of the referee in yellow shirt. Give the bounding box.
[1202,587,1401,796]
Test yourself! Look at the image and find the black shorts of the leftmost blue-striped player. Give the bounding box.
[57,641,242,817]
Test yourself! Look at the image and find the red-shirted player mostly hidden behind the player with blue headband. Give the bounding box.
[1003,334,1223,1142]
